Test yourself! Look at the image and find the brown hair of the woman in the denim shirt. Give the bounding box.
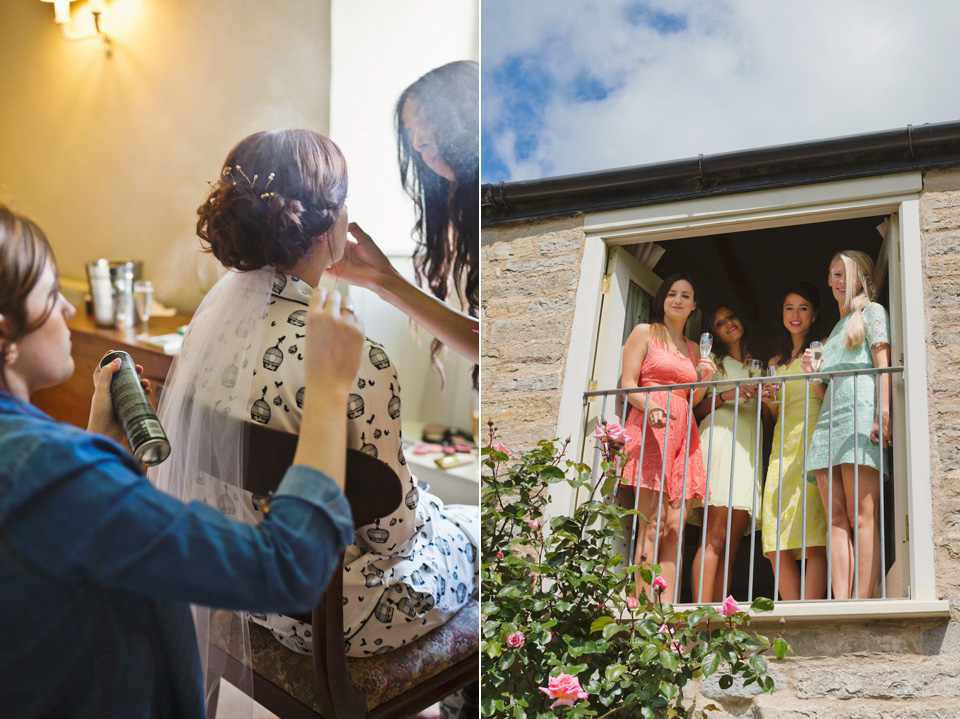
[0,204,57,389]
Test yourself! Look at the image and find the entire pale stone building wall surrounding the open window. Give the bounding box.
[482,169,960,719]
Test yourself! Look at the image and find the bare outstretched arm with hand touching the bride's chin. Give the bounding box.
[326,222,480,364]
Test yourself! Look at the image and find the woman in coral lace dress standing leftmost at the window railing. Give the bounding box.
[620,274,716,592]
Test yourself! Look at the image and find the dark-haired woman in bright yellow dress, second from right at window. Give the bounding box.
[762,282,827,599]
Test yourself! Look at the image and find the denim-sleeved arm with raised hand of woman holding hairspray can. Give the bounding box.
[5,288,363,611]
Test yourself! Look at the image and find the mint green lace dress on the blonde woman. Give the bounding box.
[807,302,890,482]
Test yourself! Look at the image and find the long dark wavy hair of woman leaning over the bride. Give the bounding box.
[394,60,480,384]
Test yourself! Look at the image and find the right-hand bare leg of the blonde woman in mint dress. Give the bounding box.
[841,464,880,599]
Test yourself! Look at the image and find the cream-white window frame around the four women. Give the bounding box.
[553,172,949,620]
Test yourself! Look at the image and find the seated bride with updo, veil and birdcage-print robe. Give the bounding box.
[154,130,479,704]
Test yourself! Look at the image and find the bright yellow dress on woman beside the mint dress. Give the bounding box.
[762,357,827,559]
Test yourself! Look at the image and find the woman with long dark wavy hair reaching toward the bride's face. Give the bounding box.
[328,61,480,372]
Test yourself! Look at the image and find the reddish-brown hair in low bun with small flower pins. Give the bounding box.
[197,130,347,271]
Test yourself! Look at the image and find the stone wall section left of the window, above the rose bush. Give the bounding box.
[480,215,584,450]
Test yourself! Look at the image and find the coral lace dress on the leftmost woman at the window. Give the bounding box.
[621,337,706,504]
